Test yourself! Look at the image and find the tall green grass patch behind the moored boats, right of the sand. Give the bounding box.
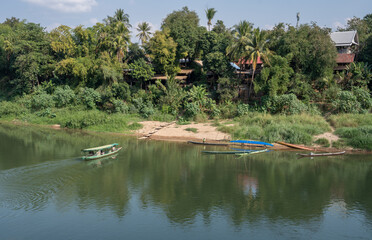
[219,113,330,144]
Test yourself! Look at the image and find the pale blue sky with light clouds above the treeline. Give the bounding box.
[0,0,372,42]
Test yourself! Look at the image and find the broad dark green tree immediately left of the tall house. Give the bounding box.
[268,23,337,81]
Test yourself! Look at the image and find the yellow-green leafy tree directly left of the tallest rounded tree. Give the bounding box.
[146,31,178,76]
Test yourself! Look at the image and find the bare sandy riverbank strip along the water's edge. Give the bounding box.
[0,118,371,153]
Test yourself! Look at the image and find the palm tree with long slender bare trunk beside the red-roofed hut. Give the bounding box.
[244,28,271,94]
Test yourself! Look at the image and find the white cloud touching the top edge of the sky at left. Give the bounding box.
[24,0,97,13]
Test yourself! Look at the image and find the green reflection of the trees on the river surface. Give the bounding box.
[0,122,372,238]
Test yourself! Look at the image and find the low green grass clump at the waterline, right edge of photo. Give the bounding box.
[335,126,372,151]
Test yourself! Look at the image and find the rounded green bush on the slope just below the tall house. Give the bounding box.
[332,91,361,113]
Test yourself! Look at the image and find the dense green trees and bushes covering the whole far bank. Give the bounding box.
[0,7,372,149]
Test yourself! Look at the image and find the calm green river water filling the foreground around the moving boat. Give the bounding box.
[0,124,372,240]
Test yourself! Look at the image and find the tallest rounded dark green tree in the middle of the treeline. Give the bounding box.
[161,7,200,59]
